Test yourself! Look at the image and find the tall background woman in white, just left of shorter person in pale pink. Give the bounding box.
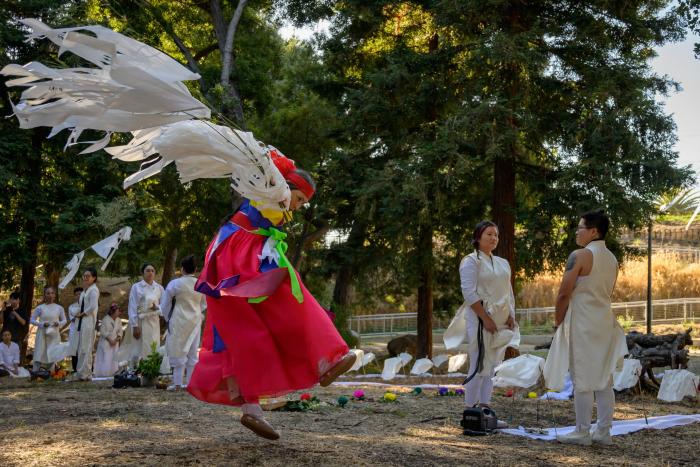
[68,267,100,381]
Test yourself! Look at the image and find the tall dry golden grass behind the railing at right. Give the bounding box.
[518,253,700,308]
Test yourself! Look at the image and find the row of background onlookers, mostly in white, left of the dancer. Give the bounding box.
[0,256,206,389]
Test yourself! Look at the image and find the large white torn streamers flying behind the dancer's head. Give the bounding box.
[0,19,290,207]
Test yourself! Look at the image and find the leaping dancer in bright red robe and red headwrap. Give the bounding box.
[187,153,355,439]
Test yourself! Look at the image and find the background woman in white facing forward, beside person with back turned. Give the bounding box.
[119,263,163,368]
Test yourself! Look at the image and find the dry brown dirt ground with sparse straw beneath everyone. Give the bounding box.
[0,378,700,466]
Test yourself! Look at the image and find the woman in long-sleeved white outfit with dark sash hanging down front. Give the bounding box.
[455,221,519,418]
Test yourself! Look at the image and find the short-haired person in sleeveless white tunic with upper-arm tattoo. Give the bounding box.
[544,211,628,446]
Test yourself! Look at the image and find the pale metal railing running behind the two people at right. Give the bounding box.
[350,298,700,337]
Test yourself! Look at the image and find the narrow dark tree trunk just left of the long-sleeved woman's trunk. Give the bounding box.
[416,225,433,358]
